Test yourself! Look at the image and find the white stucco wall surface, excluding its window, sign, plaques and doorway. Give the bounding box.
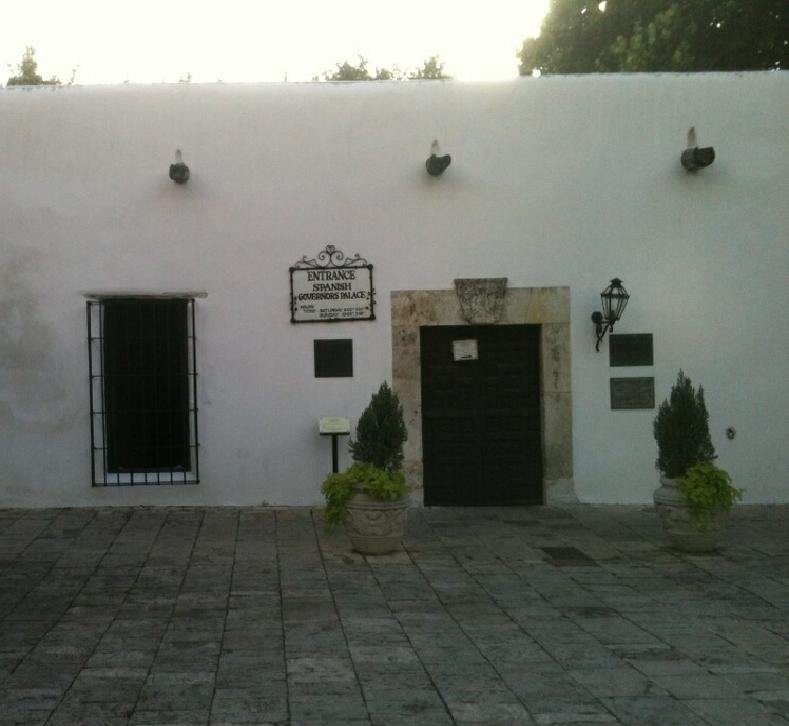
[0,72,789,506]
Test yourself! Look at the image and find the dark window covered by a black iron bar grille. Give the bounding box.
[87,297,200,486]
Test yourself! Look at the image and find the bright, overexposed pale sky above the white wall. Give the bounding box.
[0,0,549,85]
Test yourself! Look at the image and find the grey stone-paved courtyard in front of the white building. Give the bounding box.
[0,506,789,726]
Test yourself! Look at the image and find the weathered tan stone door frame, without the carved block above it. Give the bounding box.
[391,287,577,504]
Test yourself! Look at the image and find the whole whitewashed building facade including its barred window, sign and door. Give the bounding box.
[0,72,789,507]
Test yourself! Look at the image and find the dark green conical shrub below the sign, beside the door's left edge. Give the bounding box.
[350,381,408,471]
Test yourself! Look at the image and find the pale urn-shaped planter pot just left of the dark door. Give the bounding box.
[344,493,410,555]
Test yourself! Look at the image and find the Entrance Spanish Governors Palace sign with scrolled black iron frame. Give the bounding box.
[290,245,375,323]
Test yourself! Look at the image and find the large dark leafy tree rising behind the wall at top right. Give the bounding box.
[519,0,789,75]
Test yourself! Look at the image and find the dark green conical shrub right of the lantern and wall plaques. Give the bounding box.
[654,371,715,479]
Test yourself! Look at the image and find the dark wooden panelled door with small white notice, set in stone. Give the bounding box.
[420,325,543,506]
